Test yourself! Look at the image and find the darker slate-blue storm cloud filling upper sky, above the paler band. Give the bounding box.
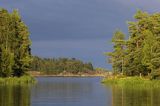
[2,0,131,40]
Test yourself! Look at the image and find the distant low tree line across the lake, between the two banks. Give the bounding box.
[31,56,94,74]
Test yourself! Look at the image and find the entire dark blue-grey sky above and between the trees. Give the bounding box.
[0,0,160,69]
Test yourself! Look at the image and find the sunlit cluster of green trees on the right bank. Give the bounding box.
[107,10,160,78]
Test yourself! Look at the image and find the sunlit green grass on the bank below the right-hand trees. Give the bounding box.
[102,77,160,88]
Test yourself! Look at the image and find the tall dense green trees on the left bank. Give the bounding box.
[0,8,32,77]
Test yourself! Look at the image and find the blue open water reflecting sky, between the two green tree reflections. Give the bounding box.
[31,77,111,106]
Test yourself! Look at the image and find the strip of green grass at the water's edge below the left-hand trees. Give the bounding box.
[0,76,36,85]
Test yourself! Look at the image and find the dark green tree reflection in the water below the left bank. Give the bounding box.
[0,85,30,106]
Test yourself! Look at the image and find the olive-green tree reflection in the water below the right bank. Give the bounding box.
[112,86,160,106]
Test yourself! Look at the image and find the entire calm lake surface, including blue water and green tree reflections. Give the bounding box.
[0,77,160,106]
